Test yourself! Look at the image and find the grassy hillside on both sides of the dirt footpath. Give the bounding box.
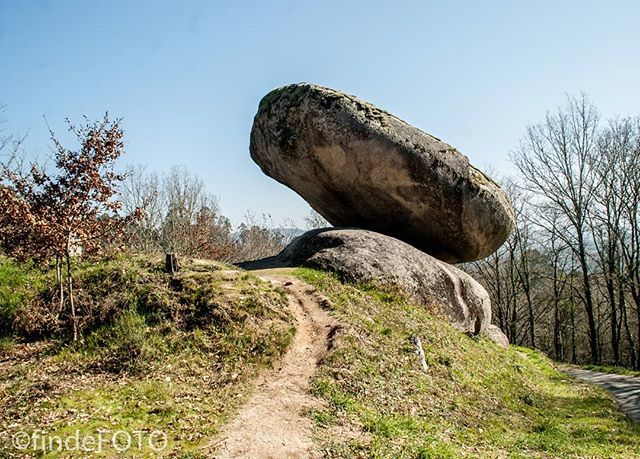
[0,258,640,459]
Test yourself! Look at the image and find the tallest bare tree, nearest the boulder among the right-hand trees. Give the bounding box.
[513,94,600,363]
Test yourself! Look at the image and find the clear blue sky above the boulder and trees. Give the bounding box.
[0,0,640,224]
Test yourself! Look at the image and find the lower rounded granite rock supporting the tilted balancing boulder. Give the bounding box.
[240,229,491,335]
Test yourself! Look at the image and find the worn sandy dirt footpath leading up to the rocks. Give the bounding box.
[215,273,334,459]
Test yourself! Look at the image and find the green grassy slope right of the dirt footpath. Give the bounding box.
[296,269,640,458]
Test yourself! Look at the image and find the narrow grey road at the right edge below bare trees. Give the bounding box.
[563,368,640,422]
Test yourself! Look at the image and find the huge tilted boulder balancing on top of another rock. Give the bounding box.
[250,84,514,263]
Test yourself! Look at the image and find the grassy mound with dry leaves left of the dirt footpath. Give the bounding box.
[0,258,295,458]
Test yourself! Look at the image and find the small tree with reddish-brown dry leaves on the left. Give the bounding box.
[0,114,139,341]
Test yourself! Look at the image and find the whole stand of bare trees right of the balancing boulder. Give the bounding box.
[462,96,640,368]
